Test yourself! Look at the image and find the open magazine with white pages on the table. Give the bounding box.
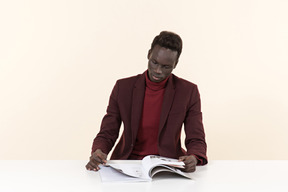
[100,155,192,182]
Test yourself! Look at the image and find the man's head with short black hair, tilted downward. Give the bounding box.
[148,31,182,82]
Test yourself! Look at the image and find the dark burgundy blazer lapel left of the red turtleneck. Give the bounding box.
[131,74,145,144]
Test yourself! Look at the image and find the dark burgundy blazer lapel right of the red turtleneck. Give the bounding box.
[159,75,175,135]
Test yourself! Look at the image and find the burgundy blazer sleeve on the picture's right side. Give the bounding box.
[184,85,208,165]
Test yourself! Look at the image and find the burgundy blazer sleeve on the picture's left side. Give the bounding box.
[92,81,121,154]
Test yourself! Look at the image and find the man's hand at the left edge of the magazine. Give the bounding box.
[86,149,107,171]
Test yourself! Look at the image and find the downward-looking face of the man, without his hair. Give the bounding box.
[148,45,178,82]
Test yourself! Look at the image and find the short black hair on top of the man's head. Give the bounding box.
[150,31,182,59]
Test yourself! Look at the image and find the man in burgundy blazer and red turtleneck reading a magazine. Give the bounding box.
[86,31,207,172]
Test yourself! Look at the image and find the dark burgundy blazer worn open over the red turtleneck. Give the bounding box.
[92,73,207,164]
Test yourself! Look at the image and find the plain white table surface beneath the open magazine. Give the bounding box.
[0,160,288,192]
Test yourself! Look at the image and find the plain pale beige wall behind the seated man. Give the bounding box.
[0,0,288,159]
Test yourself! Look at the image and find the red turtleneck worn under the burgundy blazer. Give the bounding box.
[129,71,169,159]
